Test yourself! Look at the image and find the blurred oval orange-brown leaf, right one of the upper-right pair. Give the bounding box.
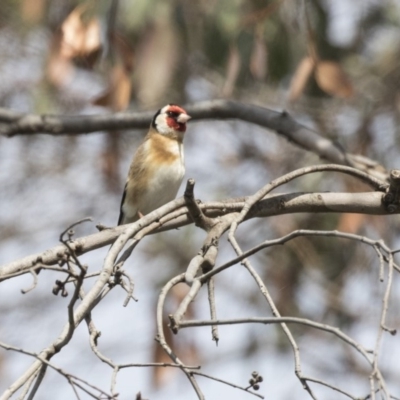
[315,61,354,98]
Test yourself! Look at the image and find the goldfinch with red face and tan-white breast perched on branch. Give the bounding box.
[118,104,191,225]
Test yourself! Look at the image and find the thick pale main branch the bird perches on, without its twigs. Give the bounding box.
[0,192,391,281]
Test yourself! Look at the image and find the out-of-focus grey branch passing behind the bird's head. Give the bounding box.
[0,100,387,179]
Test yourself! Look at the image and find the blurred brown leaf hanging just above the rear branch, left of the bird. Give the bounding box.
[92,62,132,111]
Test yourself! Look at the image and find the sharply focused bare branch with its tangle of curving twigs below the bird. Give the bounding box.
[0,165,399,399]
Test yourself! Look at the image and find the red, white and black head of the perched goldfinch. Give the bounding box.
[151,104,191,137]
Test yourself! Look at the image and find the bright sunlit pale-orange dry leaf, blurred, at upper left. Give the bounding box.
[60,5,101,66]
